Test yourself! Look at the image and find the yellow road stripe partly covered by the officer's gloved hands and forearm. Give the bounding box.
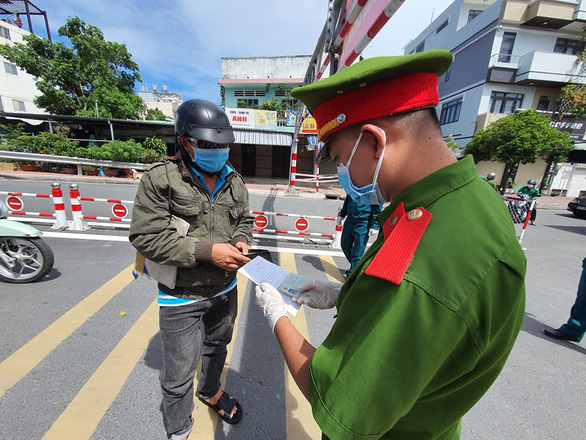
[280,253,321,440]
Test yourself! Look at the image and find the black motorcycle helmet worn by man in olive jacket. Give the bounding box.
[175,99,234,144]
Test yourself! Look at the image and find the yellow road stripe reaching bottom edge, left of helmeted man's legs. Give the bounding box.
[43,300,159,440]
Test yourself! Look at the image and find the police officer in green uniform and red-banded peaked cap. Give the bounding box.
[256,50,526,440]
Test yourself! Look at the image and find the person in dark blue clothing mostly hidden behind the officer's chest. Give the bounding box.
[340,197,382,277]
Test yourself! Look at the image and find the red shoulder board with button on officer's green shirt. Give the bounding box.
[364,202,432,285]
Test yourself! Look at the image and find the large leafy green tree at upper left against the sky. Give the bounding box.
[0,17,146,119]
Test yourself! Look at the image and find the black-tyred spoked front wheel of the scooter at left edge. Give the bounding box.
[0,237,55,284]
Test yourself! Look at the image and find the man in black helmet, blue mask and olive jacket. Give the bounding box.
[129,99,253,440]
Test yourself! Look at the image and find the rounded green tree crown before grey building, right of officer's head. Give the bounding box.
[464,109,574,164]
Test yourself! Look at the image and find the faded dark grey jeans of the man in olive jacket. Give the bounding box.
[159,288,238,437]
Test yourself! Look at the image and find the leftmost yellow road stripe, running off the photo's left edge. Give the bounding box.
[0,265,132,397]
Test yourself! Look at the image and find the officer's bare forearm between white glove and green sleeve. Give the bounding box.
[275,317,315,400]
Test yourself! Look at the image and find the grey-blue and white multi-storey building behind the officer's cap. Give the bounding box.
[405,0,586,195]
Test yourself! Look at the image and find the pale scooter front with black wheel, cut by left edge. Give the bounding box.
[0,200,55,283]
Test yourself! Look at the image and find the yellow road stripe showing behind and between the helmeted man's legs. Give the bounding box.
[189,274,248,440]
